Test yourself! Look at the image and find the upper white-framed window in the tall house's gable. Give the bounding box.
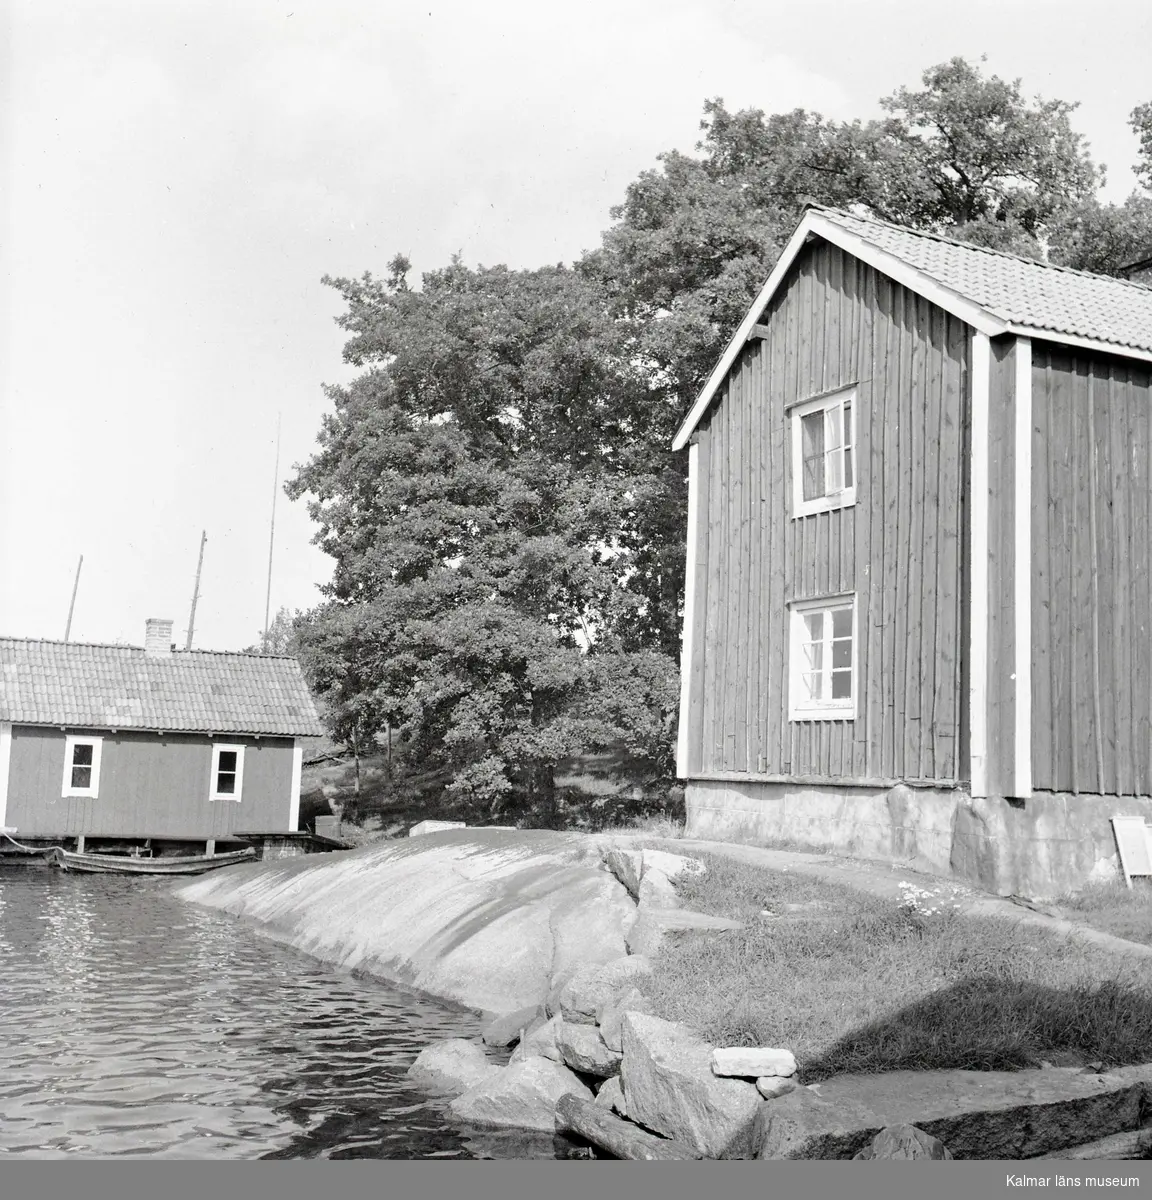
[792,388,856,517]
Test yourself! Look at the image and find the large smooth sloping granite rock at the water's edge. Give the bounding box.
[178,828,636,1013]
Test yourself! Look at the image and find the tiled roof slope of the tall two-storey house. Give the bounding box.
[812,205,1152,350]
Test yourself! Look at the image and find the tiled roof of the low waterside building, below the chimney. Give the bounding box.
[0,637,324,737]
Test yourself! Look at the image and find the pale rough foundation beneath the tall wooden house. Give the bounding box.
[684,780,1152,898]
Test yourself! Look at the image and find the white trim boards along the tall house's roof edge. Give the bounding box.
[672,209,1152,450]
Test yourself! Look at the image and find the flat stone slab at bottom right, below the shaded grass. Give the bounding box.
[758,1067,1152,1159]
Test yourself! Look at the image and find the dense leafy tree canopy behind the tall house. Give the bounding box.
[288,59,1152,825]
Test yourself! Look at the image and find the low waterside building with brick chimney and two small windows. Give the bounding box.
[0,620,323,850]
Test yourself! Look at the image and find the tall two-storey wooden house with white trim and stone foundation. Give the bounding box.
[674,206,1152,895]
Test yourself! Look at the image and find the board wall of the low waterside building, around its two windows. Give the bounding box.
[8,726,293,839]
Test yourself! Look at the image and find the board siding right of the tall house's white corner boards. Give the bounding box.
[1032,342,1152,796]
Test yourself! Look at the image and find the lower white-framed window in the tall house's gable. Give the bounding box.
[788,596,856,721]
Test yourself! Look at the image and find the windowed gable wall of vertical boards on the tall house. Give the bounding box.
[689,242,967,780]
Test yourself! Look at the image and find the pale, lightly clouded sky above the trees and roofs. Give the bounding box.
[0,0,1152,649]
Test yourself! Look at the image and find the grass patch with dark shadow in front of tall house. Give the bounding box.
[647,853,1152,1082]
